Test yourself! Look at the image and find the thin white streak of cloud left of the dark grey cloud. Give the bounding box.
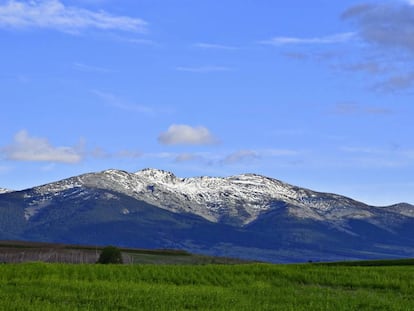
[260,32,355,45]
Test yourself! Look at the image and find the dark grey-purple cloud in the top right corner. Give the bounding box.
[342,1,414,93]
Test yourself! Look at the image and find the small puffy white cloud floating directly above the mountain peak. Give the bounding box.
[158,124,217,145]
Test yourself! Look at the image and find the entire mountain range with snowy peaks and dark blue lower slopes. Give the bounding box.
[0,169,414,262]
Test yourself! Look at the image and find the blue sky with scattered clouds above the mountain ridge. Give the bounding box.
[0,0,414,205]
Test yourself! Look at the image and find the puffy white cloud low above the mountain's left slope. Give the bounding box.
[0,130,82,163]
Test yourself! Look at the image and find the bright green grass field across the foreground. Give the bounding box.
[0,263,414,311]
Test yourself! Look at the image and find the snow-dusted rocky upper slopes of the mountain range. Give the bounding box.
[25,168,414,225]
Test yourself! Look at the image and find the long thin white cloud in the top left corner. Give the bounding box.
[0,0,147,33]
